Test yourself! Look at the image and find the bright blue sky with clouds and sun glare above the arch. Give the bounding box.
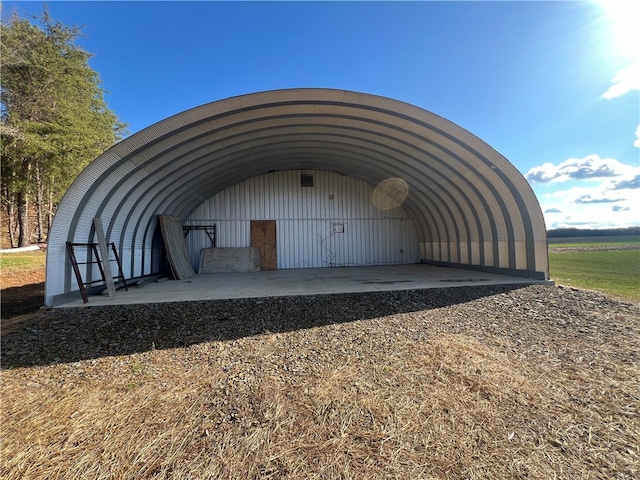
[2,0,640,228]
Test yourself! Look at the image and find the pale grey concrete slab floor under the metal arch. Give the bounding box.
[56,264,553,308]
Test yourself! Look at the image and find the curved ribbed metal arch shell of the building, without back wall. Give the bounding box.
[46,89,548,304]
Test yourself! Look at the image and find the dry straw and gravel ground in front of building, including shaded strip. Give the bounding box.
[0,280,640,479]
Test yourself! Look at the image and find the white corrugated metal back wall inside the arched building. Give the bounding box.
[185,170,420,268]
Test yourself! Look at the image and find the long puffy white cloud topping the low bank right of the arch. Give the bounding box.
[525,154,640,183]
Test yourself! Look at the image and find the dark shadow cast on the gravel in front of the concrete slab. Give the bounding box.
[1,284,526,369]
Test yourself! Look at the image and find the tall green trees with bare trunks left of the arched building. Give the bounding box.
[0,9,126,247]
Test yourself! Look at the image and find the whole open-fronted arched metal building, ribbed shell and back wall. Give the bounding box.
[45,89,548,305]
